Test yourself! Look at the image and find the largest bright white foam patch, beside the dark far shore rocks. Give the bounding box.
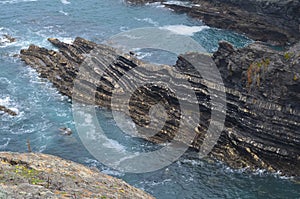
[161,25,209,36]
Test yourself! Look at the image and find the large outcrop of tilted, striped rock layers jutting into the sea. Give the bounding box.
[21,38,300,176]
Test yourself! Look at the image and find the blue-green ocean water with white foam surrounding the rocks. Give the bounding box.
[0,0,300,198]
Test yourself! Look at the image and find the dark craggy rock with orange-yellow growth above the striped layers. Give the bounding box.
[213,42,300,107]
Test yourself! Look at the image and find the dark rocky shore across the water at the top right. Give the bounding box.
[126,0,300,45]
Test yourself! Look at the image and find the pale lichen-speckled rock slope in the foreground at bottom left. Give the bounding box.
[0,152,153,199]
